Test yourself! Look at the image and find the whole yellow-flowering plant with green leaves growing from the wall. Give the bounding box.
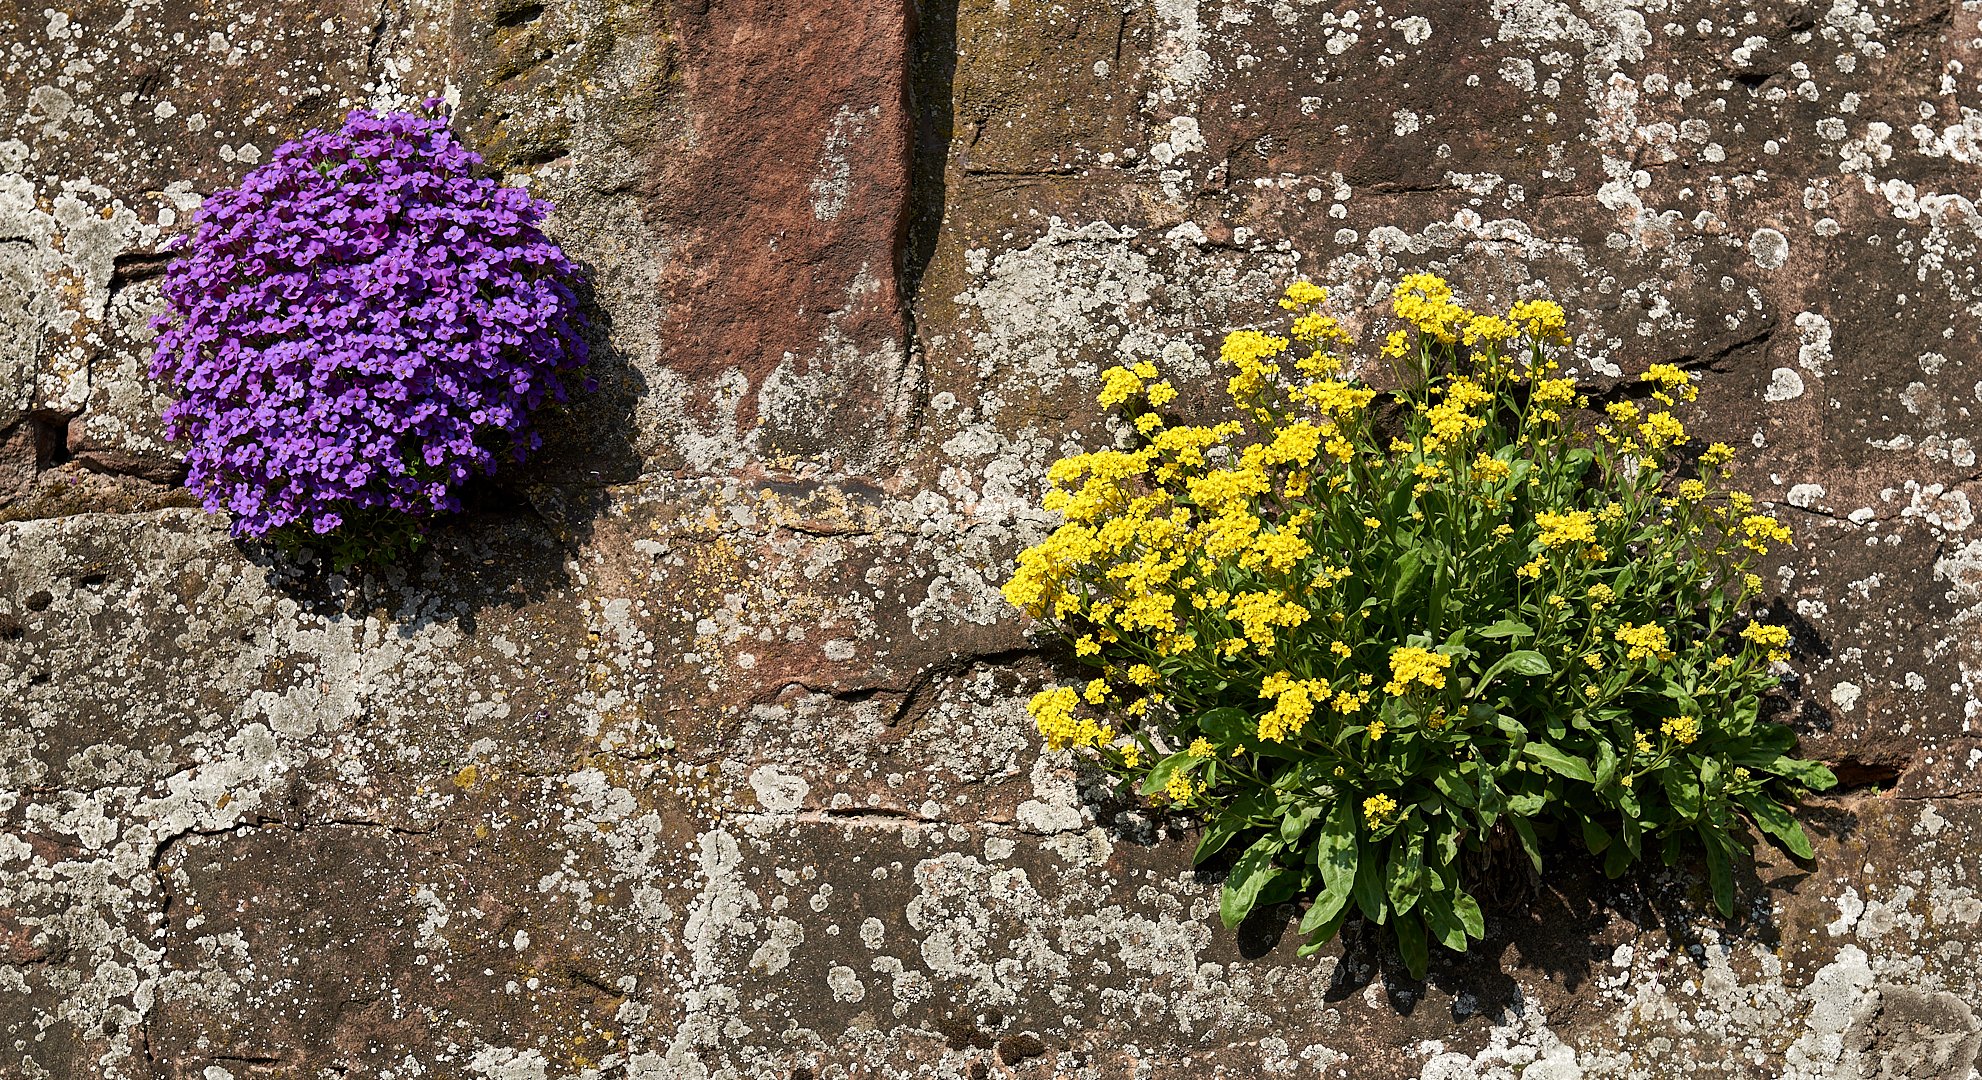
[1005,273,1835,975]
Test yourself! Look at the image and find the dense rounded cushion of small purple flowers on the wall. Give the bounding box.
[151,103,591,537]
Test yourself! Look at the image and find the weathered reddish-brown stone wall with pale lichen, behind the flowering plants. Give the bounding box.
[11,0,1982,1080]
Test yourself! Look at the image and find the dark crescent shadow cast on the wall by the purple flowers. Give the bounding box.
[247,264,648,634]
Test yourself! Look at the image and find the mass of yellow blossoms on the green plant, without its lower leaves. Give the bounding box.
[1005,273,1790,911]
